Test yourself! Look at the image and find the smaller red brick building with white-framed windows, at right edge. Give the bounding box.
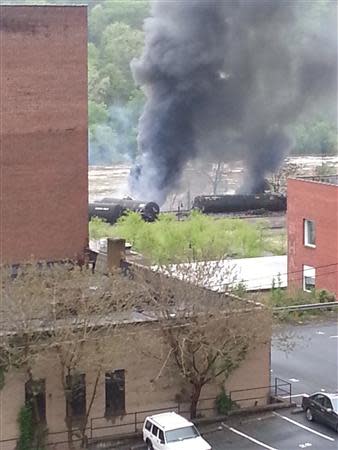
[287,175,338,297]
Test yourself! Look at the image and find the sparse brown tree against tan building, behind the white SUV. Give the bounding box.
[145,263,271,418]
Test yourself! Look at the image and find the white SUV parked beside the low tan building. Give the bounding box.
[143,412,211,450]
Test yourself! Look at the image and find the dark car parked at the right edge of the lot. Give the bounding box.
[302,392,338,433]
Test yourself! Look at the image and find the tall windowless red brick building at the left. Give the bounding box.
[0,6,88,263]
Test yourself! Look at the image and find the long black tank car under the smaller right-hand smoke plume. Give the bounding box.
[193,193,286,213]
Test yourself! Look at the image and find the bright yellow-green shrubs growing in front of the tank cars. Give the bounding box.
[89,211,278,264]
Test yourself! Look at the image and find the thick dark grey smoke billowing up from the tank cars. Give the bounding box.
[130,0,337,204]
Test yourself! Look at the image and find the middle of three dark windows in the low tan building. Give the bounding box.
[66,373,86,418]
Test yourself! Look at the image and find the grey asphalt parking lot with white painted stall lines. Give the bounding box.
[115,320,338,450]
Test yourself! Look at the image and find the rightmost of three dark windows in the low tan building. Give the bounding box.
[105,370,125,416]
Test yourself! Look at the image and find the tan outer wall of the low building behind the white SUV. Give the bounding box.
[0,323,270,450]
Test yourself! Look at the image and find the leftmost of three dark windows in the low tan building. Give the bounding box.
[25,379,46,424]
